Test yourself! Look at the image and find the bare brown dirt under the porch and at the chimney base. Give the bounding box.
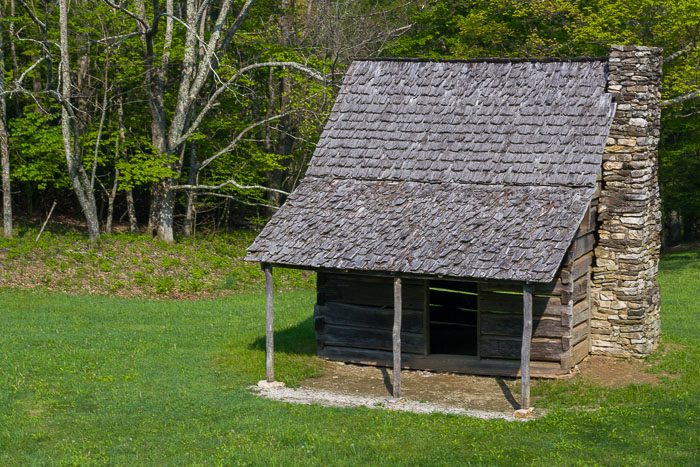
[301,356,659,413]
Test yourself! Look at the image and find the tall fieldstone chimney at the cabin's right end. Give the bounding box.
[591,46,663,357]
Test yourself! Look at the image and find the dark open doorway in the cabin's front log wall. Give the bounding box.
[428,280,479,357]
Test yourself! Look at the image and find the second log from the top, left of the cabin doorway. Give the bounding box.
[314,302,423,333]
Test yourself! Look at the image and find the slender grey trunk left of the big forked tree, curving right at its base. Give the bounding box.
[58,0,100,242]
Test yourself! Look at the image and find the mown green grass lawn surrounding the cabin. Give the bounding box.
[0,252,700,465]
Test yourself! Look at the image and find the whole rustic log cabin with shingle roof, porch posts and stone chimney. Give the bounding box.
[246,46,661,406]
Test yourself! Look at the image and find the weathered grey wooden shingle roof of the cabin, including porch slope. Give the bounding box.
[246,60,614,282]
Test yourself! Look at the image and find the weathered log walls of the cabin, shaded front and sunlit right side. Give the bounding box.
[314,201,597,376]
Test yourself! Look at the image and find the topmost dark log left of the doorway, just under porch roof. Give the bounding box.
[319,273,425,310]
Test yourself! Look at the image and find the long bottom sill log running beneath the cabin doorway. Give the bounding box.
[319,346,569,378]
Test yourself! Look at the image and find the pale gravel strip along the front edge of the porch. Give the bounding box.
[250,386,523,421]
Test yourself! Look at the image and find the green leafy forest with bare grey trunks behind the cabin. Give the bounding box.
[0,0,700,243]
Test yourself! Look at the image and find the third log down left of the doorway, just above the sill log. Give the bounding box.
[316,323,425,354]
